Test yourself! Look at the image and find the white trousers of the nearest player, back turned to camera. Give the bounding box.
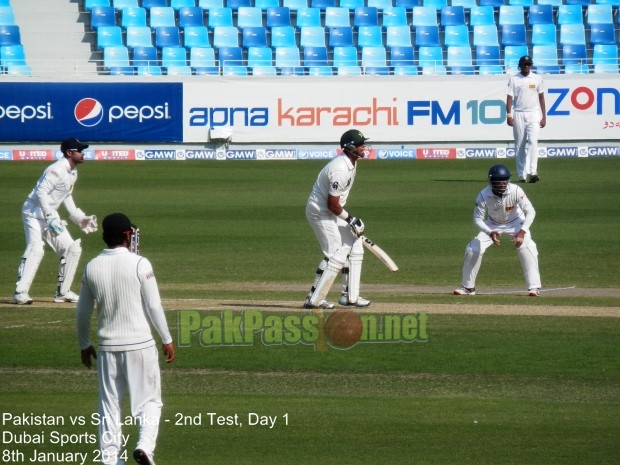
[97,345,162,465]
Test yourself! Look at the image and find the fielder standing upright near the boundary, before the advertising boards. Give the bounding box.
[506,55,547,182]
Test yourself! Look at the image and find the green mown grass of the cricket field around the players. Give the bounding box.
[0,158,620,465]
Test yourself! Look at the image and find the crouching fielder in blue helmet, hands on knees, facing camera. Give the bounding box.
[454,165,541,297]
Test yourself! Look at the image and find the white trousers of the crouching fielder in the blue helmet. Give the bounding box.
[461,219,541,289]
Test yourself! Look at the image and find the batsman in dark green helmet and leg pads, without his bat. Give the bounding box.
[304,129,370,309]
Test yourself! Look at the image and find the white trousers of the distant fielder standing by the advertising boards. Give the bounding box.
[512,111,542,179]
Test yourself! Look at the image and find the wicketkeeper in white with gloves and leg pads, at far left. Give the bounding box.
[11,139,97,305]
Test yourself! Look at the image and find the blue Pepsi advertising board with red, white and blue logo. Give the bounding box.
[0,83,183,142]
